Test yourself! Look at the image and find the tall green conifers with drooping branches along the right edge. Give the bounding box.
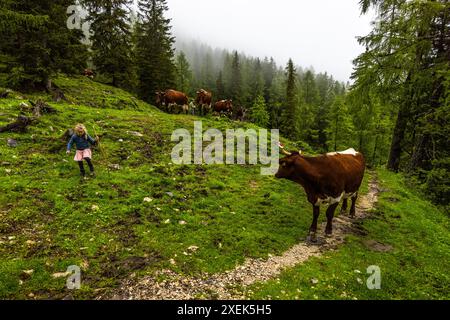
[353,0,450,203]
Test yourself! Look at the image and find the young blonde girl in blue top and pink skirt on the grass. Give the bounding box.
[67,123,97,178]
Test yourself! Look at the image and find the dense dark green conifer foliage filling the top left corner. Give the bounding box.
[0,0,87,90]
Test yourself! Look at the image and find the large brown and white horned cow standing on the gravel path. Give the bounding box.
[275,147,366,242]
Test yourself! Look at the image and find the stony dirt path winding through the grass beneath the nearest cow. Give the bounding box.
[104,179,379,300]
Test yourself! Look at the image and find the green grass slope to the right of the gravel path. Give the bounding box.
[248,170,450,299]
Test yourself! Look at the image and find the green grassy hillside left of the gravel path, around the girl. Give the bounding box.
[0,77,311,299]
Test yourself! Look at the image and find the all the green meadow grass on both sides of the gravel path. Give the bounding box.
[0,76,449,299]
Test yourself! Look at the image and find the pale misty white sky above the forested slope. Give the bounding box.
[167,0,372,81]
